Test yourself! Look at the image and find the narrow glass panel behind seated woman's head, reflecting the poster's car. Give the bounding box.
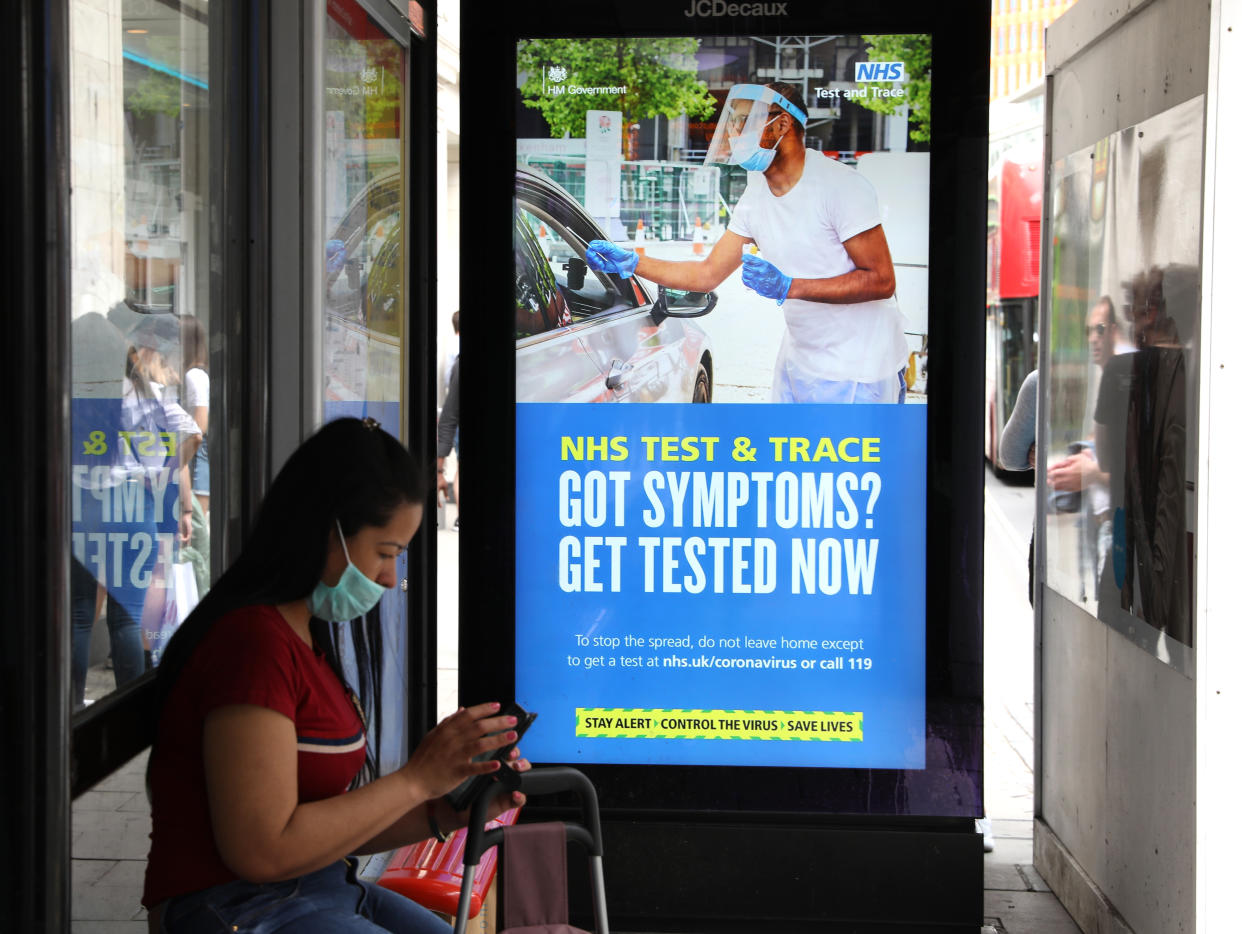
[318,0,409,771]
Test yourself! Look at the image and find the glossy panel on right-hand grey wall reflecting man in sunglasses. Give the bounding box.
[1043,98,1203,673]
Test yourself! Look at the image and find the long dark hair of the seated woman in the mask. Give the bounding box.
[150,419,428,784]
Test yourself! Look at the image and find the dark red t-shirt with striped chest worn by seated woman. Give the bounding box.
[143,606,366,907]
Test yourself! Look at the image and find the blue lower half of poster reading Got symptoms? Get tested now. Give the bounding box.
[514,404,927,769]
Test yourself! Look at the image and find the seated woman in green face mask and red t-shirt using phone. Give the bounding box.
[143,419,530,934]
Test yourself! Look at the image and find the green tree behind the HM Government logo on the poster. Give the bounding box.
[518,39,717,159]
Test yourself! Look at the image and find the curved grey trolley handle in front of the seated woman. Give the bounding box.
[453,766,609,934]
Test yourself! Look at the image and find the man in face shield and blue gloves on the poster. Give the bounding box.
[586,82,908,402]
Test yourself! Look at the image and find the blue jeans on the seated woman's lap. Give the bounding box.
[160,858,451,934]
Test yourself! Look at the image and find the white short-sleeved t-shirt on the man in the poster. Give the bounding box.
[729,149,908,383]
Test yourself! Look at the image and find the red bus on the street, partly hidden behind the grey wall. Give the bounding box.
[984,153,1043,472]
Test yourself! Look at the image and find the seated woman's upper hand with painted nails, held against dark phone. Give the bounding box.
[401,703,519,801]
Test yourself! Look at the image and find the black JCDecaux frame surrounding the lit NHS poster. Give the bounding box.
[460,0,989,930]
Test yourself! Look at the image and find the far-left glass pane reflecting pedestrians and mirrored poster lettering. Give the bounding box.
[70,0,211,709]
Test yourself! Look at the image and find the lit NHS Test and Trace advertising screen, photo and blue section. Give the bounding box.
[512,32,935,770]
